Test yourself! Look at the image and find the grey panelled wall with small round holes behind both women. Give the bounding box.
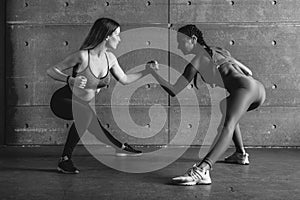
[4,0,300,146]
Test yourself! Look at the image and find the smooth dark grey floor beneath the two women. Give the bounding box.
[0,146,300,200]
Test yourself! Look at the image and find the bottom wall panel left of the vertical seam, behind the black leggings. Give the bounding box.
[6,106,168,145]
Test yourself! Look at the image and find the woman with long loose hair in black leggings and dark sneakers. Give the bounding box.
[47,18,147,174]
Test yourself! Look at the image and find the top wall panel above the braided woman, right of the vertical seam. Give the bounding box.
[170,0,300,23]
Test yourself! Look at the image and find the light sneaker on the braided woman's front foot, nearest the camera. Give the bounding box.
[172,164,211,186]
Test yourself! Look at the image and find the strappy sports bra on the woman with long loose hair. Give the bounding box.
[72,51,110,89]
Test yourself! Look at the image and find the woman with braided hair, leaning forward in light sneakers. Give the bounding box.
[147,25,266,185]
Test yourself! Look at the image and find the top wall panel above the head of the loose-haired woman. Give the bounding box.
[7,0,168,24]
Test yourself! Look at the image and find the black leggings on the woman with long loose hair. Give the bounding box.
[50,85,122,158]
